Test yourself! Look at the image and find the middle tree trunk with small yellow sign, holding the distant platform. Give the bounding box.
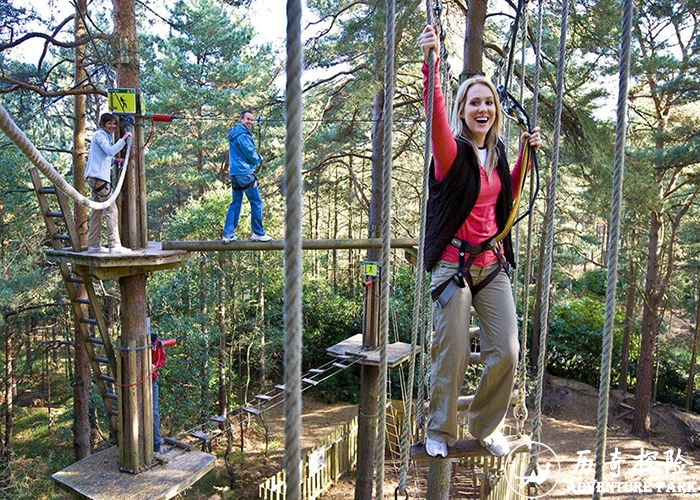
[355,88,388,500]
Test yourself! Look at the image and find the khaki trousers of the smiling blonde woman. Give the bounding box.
[427,261,519,446]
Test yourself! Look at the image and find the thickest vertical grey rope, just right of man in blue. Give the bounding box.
[284,0,303,500]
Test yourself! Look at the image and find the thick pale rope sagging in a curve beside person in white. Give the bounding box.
[0,104,131,210]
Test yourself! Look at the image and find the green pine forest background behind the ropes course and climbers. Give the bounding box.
[0,0,700,498]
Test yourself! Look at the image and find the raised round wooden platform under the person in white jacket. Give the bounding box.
[44,242,188,280]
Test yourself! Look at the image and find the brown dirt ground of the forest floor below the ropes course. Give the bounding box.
[227,377,700,500]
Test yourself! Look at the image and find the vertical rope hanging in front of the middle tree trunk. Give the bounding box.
[375,0,396,498]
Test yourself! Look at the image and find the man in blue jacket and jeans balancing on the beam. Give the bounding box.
[222,109,272,243]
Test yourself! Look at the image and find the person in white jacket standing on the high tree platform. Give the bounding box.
[85,113,131,253]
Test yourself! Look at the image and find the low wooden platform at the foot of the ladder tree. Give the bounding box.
[52,446,216,500]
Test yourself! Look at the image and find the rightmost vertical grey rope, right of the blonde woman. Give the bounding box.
[593,0,634,500]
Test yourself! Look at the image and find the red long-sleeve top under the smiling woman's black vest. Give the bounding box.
[423,58,523,267]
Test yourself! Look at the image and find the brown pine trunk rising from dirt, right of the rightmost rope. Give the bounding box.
[632,212,661,439]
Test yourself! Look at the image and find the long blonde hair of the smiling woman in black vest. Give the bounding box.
[451,76,503,181]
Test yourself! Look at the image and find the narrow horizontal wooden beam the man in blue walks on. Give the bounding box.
[162,238,418,252]
